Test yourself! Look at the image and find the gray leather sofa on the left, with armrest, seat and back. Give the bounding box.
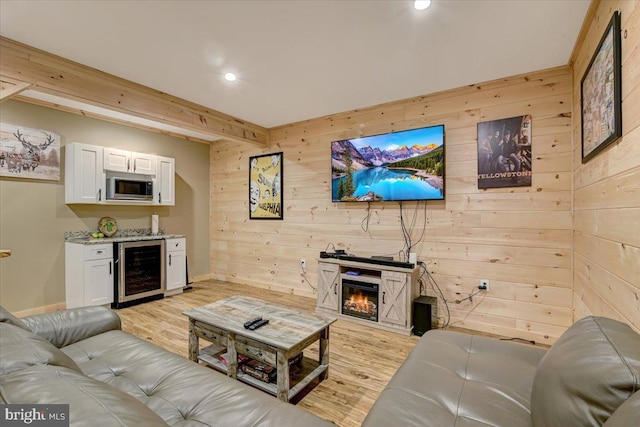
[0,307,333,427]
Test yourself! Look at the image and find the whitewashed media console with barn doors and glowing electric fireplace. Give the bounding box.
[316,258,419,335]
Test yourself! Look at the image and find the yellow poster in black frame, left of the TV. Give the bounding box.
[249,152,283,219]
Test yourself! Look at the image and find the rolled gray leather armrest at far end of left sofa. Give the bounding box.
[20,306,121,348]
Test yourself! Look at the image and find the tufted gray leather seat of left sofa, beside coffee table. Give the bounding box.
[62,331,331,427]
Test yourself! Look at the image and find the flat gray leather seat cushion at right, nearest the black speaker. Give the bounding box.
[362,330,546,427]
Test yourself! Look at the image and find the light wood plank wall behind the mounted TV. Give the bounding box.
[211,66,573,344]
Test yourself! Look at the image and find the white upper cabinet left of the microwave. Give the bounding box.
[64,142,107,204]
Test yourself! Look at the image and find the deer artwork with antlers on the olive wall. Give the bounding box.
[0,123,60,181]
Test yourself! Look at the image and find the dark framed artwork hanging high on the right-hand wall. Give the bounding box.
[580,11,622,163]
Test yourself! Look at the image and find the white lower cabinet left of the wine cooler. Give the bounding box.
[65,243,115,308]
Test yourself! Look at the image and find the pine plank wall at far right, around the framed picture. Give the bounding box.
[573,1,640,331]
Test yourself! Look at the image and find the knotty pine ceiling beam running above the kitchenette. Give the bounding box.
[0,37,268,146]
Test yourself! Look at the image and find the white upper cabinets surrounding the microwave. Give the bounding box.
[65,142,176,206]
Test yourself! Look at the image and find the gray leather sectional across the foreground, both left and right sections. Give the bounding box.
[0,307,640,427]
